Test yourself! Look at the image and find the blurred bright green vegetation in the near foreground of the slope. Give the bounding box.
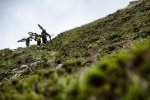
[0,37,150,100]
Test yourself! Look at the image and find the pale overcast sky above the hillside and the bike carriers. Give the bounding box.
[0,0,131,49]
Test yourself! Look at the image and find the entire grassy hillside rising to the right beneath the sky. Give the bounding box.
[0,0,150,100]
